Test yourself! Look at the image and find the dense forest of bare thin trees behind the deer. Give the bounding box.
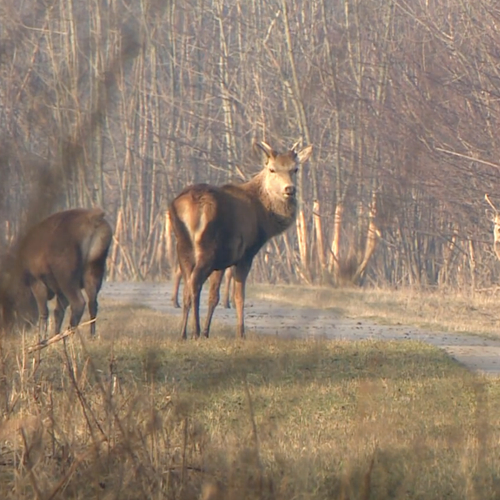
[0,0,500,290]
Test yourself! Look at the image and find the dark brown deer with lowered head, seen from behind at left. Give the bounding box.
[12,208,113,338]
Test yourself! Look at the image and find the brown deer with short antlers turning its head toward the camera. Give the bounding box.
[169,142,312,339]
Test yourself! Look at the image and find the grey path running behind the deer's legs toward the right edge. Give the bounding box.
[100,282,500,375]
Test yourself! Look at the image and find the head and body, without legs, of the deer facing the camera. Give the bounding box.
[170,142,312,269]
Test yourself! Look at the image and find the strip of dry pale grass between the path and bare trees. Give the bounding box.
[249,285,500,338]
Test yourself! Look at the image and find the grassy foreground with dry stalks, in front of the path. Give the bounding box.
[0,287,500,500]
